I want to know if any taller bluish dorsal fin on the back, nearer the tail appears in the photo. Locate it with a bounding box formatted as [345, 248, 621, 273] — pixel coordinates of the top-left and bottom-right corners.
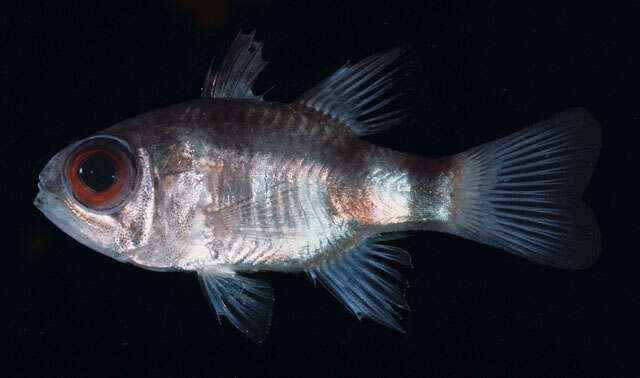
[296, 47, 405, 136]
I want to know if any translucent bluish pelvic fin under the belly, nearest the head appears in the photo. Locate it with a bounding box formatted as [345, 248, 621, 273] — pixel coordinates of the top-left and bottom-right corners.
[198, 269, 274, 344]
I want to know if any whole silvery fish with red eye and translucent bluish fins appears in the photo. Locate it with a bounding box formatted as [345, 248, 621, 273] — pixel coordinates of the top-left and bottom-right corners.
[34, 32, 601, 344]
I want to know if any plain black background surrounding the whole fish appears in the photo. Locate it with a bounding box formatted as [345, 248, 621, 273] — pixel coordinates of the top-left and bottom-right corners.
[0, 0, 640, 377]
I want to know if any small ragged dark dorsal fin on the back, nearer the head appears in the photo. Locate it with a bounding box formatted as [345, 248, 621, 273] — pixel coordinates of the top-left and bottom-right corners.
[202, 31, 267, 101]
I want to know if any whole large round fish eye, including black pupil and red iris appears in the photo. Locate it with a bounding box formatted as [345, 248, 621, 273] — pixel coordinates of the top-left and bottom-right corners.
[64, 137, 136, 210]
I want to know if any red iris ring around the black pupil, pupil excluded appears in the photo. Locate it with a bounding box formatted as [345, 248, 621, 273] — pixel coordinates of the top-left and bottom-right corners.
[65, 138, 135, 210]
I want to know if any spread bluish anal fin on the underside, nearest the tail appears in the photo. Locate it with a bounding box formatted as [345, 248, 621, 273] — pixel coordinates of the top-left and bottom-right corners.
[307, 236, 411, 333]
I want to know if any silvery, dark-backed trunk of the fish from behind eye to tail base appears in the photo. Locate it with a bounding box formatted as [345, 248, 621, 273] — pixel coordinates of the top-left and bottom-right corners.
[38, 99, 454, 271]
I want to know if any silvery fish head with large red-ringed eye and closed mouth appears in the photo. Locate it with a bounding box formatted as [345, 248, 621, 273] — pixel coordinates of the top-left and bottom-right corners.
[34, 134, 163, 269]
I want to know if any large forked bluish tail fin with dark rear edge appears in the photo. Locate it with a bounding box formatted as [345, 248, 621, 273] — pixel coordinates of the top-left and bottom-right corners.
[449, 109, 601, 269]
